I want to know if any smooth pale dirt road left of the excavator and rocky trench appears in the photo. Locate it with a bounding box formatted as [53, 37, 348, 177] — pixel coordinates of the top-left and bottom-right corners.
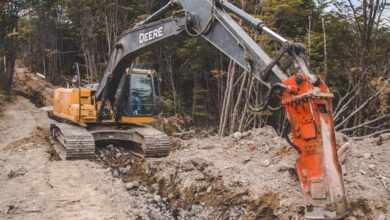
[0, 96, 136, 219]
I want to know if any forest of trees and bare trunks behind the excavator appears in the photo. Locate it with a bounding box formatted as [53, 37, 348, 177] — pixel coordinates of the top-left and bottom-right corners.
[0, 0, 390, 139]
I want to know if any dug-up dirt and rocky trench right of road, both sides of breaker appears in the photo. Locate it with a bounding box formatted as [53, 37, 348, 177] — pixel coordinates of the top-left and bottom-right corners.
[99, 127, 390, 219]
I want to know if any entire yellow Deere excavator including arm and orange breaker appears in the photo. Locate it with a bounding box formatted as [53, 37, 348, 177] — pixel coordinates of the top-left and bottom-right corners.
[50, 0, 349, 219]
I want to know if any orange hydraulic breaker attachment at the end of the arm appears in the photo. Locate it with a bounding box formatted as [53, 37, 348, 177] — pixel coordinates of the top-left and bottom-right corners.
[281, 73, 349, 219]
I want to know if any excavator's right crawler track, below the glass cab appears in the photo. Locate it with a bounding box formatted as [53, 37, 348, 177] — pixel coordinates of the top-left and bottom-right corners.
[88, 124, 171, 158]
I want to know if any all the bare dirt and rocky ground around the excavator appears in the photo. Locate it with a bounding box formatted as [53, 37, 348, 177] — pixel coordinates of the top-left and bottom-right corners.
[0, 62, 390, 220]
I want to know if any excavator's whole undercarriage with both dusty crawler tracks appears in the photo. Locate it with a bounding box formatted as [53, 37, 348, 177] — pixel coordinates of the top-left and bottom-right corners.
[50, 123, 171, 160]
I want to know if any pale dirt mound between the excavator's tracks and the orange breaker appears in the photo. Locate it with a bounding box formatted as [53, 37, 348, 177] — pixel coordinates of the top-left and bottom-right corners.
[140, 128, 303, 219]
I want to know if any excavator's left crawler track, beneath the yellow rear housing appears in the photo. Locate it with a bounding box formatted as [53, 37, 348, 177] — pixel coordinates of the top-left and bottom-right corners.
[50, 123, 95, 160]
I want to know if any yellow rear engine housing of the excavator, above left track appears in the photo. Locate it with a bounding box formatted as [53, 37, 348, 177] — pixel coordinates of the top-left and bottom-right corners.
[53, 88, 96, 123]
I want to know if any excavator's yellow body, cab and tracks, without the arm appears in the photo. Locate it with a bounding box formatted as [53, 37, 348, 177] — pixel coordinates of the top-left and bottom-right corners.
[49, 69, 171, 160]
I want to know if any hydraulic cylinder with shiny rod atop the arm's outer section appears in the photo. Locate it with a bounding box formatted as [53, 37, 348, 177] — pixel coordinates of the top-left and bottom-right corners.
[215, 0, 287, 43]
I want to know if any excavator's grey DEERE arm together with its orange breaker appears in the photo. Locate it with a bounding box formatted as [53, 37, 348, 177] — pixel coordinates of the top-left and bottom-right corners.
[96, 0, 348, 219]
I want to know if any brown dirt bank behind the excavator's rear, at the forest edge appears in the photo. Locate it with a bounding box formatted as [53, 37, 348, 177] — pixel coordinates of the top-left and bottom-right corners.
[13, 60, 55, 107]
